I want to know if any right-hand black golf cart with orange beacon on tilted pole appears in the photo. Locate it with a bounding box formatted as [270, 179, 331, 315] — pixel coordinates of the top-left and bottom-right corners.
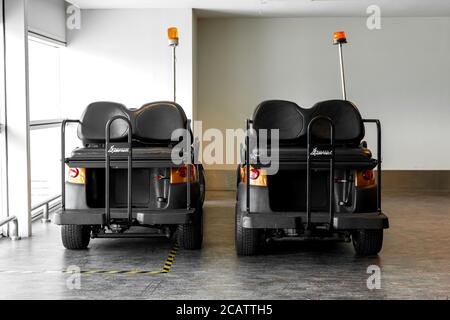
[235, 33, 389, 256]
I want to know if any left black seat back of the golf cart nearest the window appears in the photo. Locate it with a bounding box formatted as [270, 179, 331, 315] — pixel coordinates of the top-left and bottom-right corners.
[77, 101, 130, 145]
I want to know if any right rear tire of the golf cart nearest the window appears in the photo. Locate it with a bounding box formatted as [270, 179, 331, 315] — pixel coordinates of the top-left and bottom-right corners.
[178, 206, 203, 250]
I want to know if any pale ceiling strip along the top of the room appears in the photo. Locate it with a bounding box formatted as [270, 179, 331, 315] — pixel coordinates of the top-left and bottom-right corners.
[68, 0, 450, 17]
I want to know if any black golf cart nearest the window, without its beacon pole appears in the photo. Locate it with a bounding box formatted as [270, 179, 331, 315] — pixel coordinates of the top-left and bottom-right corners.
[54, 102, 205, 249]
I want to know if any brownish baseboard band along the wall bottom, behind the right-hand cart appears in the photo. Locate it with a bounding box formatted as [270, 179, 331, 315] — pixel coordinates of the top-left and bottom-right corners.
[206, 169, 450, 191]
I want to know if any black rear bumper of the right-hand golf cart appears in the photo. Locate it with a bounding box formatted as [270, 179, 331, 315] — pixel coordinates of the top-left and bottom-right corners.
[243, 212, 389, 231]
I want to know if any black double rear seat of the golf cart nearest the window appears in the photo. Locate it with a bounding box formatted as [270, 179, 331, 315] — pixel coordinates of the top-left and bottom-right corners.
[66, 102, 192, 167]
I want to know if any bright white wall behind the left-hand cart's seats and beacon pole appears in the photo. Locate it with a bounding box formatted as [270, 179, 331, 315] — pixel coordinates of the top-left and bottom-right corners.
[61, 9, 193, 118]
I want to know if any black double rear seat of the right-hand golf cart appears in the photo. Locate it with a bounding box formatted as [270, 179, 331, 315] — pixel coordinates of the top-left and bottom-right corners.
[250, 100, 377, 168]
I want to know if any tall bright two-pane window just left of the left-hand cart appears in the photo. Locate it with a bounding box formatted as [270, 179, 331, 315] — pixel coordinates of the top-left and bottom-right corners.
[28, 39, 61, 206]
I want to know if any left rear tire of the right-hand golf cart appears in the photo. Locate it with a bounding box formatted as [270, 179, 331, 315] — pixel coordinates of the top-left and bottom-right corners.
[235, 205, 259, 256]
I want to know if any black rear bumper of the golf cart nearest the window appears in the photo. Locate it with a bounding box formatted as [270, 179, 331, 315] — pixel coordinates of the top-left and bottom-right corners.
[53, 209, 195, 225]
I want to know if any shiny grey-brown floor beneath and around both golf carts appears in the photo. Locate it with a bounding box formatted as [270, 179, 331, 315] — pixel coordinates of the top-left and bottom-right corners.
[0, 192, 450, 299]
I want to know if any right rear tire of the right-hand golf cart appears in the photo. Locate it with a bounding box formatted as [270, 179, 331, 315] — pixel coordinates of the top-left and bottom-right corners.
[352, 229, 383, 256]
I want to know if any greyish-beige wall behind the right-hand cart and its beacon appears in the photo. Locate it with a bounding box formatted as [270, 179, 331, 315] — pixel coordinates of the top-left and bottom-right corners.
[197, 18, 450, 169]
